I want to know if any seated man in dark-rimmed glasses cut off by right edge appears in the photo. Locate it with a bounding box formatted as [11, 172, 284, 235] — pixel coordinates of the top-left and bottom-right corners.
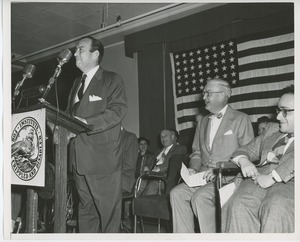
[222, 86, 295, 233]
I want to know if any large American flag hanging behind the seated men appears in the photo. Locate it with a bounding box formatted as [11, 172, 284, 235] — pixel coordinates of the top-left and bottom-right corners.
[170, 30, 294, 134]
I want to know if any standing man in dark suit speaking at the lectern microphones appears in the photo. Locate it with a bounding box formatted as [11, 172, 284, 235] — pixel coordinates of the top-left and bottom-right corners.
[67, 37, 127, 233]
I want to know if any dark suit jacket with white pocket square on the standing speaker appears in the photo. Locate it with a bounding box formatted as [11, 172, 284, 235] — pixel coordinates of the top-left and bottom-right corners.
[66, 67, 127, 174]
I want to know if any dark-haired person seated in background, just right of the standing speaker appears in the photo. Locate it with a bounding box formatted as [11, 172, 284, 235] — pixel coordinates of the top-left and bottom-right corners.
[135, 137, 153, 178]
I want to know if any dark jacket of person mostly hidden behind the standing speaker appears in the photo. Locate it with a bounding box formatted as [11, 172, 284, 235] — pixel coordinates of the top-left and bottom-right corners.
[121, 129, 139, 192]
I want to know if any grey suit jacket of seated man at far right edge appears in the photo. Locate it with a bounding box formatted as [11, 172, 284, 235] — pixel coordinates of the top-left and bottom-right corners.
[233, 123, 294, 182]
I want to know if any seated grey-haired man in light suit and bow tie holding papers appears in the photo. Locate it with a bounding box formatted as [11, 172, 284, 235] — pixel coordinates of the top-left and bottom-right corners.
[171, 79, 254, 233]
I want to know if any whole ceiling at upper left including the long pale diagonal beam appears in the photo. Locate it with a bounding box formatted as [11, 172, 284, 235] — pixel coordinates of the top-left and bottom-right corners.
[10, 1, 220, 71]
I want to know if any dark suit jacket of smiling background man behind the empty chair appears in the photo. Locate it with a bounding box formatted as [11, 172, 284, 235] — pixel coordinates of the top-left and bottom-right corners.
[147, 144, 187, 173]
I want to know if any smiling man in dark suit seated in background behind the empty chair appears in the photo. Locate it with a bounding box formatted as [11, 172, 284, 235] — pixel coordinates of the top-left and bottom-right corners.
[143, 129, 187, 195]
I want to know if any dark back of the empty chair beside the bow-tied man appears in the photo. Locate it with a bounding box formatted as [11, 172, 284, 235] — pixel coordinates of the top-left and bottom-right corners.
[165, 154, 189, 194]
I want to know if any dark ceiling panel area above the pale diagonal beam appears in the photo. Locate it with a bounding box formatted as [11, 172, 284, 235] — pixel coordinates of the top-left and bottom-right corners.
[11, 2, 170, 56]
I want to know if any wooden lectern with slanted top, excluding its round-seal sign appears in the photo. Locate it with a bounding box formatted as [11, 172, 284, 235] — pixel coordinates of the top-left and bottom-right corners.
[14, 100, 92, 233]
